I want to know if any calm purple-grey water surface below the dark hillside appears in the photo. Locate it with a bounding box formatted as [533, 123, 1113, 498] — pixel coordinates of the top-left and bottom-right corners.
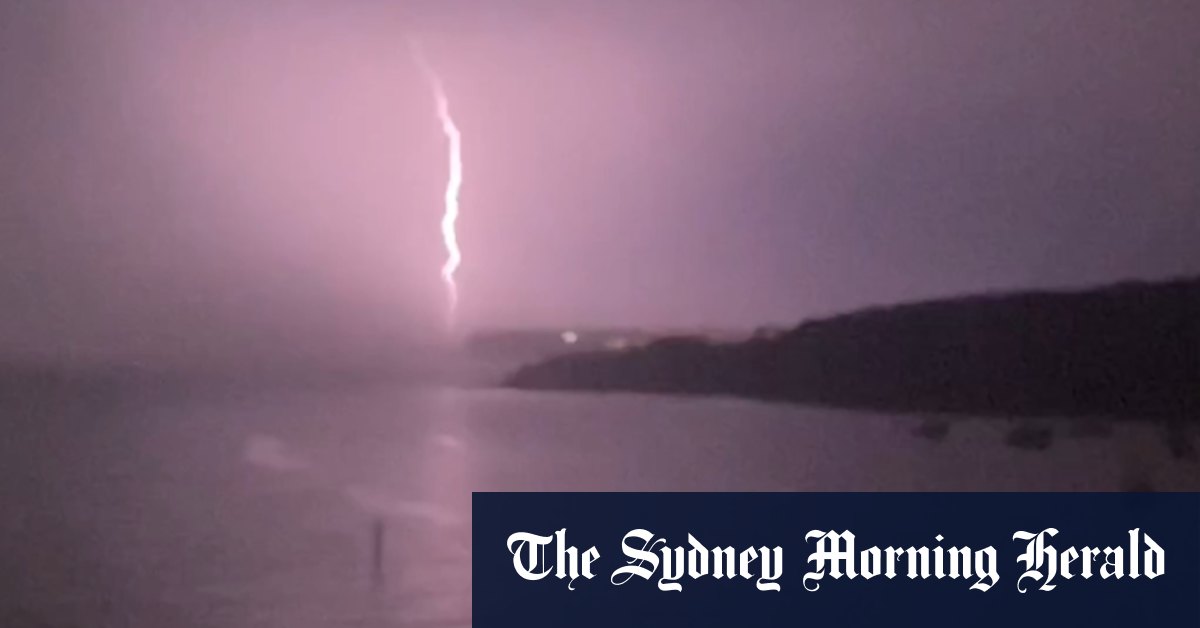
[0, 385, 1200, 628]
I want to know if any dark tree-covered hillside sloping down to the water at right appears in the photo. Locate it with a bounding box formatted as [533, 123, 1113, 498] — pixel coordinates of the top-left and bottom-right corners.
[508, 279, 1200, 417]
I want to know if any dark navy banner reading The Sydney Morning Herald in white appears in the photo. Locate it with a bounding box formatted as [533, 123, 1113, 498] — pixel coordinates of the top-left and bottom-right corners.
[473, 494, 1200, 628]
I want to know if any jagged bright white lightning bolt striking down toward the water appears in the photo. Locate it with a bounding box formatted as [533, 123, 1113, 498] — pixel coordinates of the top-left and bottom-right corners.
[408, 38, 462, 327]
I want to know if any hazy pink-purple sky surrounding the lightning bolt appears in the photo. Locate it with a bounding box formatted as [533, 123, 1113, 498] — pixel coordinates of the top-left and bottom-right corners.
[0, 0, 1200, 357]
